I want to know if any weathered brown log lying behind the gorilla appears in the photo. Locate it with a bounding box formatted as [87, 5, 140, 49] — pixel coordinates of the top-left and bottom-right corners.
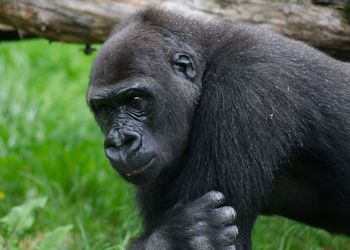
[0, 0, 350, 59]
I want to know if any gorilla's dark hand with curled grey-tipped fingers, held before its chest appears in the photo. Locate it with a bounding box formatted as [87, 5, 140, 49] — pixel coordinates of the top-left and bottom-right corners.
[131, 191, 238, 250]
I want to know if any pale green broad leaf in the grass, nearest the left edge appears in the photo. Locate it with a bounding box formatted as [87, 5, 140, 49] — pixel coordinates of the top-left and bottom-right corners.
[0, 197, 47, 234]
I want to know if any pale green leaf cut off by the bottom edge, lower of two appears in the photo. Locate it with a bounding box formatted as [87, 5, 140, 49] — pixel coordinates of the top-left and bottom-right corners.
[37, 225, 73, 250]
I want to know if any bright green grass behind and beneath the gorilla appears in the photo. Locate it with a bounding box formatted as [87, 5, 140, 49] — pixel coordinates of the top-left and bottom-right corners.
[0, 40, 350, 250]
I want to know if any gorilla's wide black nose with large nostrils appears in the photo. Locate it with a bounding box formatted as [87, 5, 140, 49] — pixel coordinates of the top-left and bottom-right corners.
[105, 131, 141, 161]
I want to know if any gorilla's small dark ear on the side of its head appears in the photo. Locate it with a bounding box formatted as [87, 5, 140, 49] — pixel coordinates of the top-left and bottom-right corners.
[171, 53, 196, 80]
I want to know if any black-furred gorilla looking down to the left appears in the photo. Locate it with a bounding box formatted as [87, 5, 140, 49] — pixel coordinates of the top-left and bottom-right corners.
[87, 7, 350, 250]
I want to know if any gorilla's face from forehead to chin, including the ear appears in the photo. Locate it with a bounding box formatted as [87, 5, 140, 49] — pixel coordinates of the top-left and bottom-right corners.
[87, 23, 200, 184]
